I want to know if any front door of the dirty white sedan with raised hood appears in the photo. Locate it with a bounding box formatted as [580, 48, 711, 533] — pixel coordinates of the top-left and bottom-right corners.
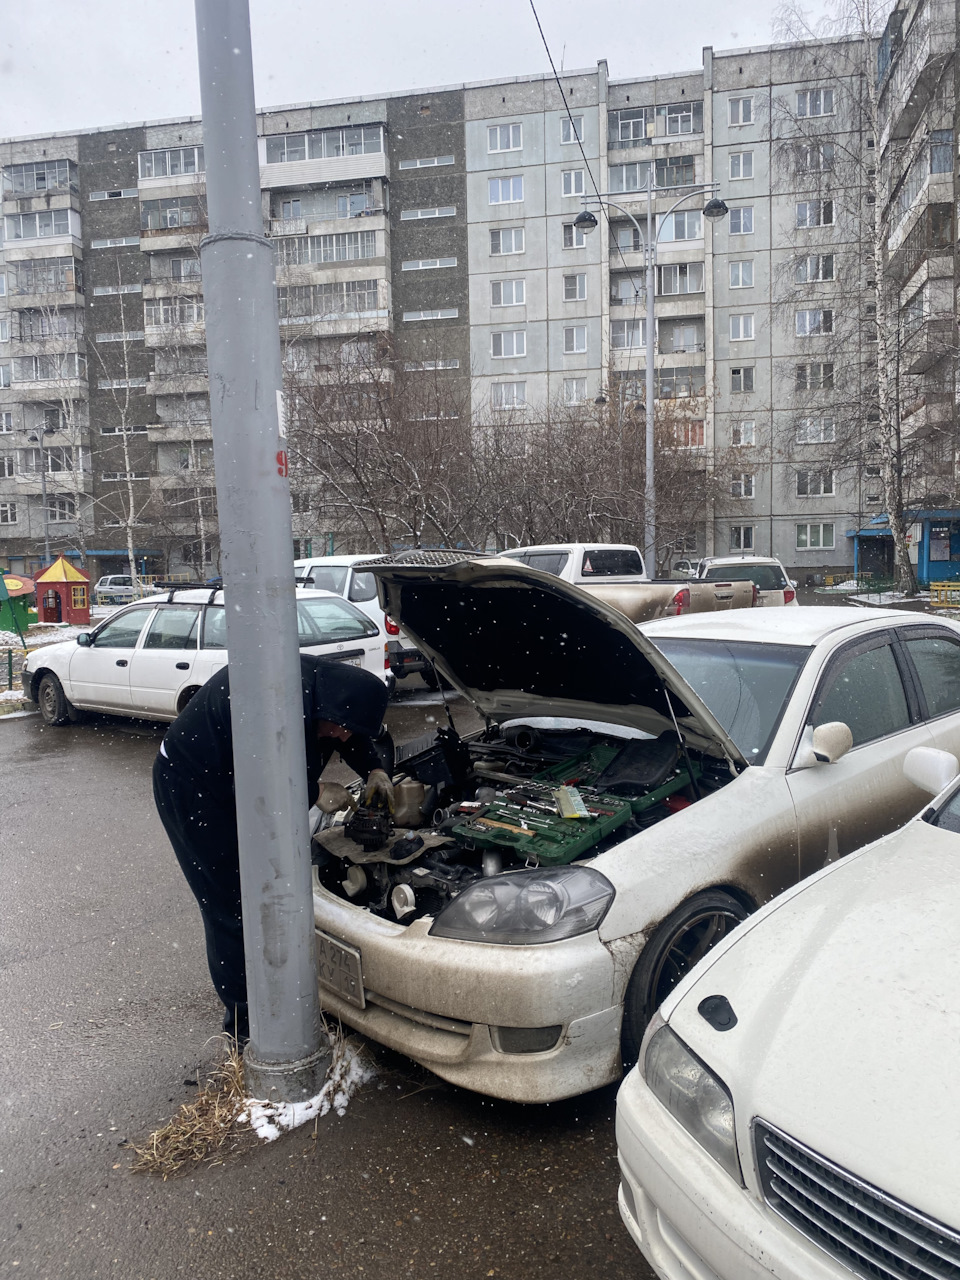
[787, 631, 931, 876]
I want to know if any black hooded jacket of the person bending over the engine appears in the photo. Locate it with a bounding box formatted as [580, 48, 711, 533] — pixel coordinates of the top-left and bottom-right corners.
[161, 654, 387, 806]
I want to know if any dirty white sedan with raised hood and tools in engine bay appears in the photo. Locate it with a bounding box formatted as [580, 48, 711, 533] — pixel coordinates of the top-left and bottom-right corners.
[308, 553, 960, 1102]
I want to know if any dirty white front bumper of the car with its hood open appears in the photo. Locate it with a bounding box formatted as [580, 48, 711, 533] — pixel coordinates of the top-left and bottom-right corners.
[314, 881, 622, 1102]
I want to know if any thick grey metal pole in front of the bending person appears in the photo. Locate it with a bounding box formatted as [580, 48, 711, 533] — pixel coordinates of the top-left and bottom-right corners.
[196, 0, 329, 1101]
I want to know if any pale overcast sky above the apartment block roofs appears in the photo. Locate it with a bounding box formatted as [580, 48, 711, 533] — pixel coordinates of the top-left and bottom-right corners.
[0, 0, 839, 137]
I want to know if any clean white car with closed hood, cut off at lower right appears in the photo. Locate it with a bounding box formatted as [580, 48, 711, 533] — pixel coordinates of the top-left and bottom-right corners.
[617, 747, 960, 1280]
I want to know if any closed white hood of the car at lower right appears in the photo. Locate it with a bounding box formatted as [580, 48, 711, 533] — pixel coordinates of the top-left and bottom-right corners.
[664, 820, 960, 1229]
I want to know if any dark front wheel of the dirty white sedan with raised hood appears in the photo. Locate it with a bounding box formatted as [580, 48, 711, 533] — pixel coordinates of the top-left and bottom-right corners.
[621, 890, 750, 1070]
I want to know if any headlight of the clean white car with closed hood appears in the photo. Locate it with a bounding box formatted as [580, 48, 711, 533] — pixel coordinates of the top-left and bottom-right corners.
[643, 1024, 744, 1187]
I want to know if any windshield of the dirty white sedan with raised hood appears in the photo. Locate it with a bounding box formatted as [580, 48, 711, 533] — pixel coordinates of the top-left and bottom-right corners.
[650, 636, 810, 764]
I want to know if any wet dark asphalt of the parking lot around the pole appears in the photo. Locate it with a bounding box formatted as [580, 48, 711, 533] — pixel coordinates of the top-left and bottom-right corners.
[0, 677, 652, 1280]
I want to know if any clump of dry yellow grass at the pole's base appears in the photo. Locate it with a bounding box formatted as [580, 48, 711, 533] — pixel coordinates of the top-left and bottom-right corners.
[131, 1041, 251, 1181]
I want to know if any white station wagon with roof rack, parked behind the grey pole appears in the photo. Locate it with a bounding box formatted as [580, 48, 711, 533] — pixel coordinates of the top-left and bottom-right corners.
[23, 588, 390, 724]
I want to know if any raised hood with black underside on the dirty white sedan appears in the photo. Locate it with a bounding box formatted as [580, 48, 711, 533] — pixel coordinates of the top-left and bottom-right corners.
[364, 552, 748, 768]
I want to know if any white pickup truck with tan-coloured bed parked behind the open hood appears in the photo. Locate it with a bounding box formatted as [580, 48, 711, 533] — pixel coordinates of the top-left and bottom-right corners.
[502, 543, 758, 622]
